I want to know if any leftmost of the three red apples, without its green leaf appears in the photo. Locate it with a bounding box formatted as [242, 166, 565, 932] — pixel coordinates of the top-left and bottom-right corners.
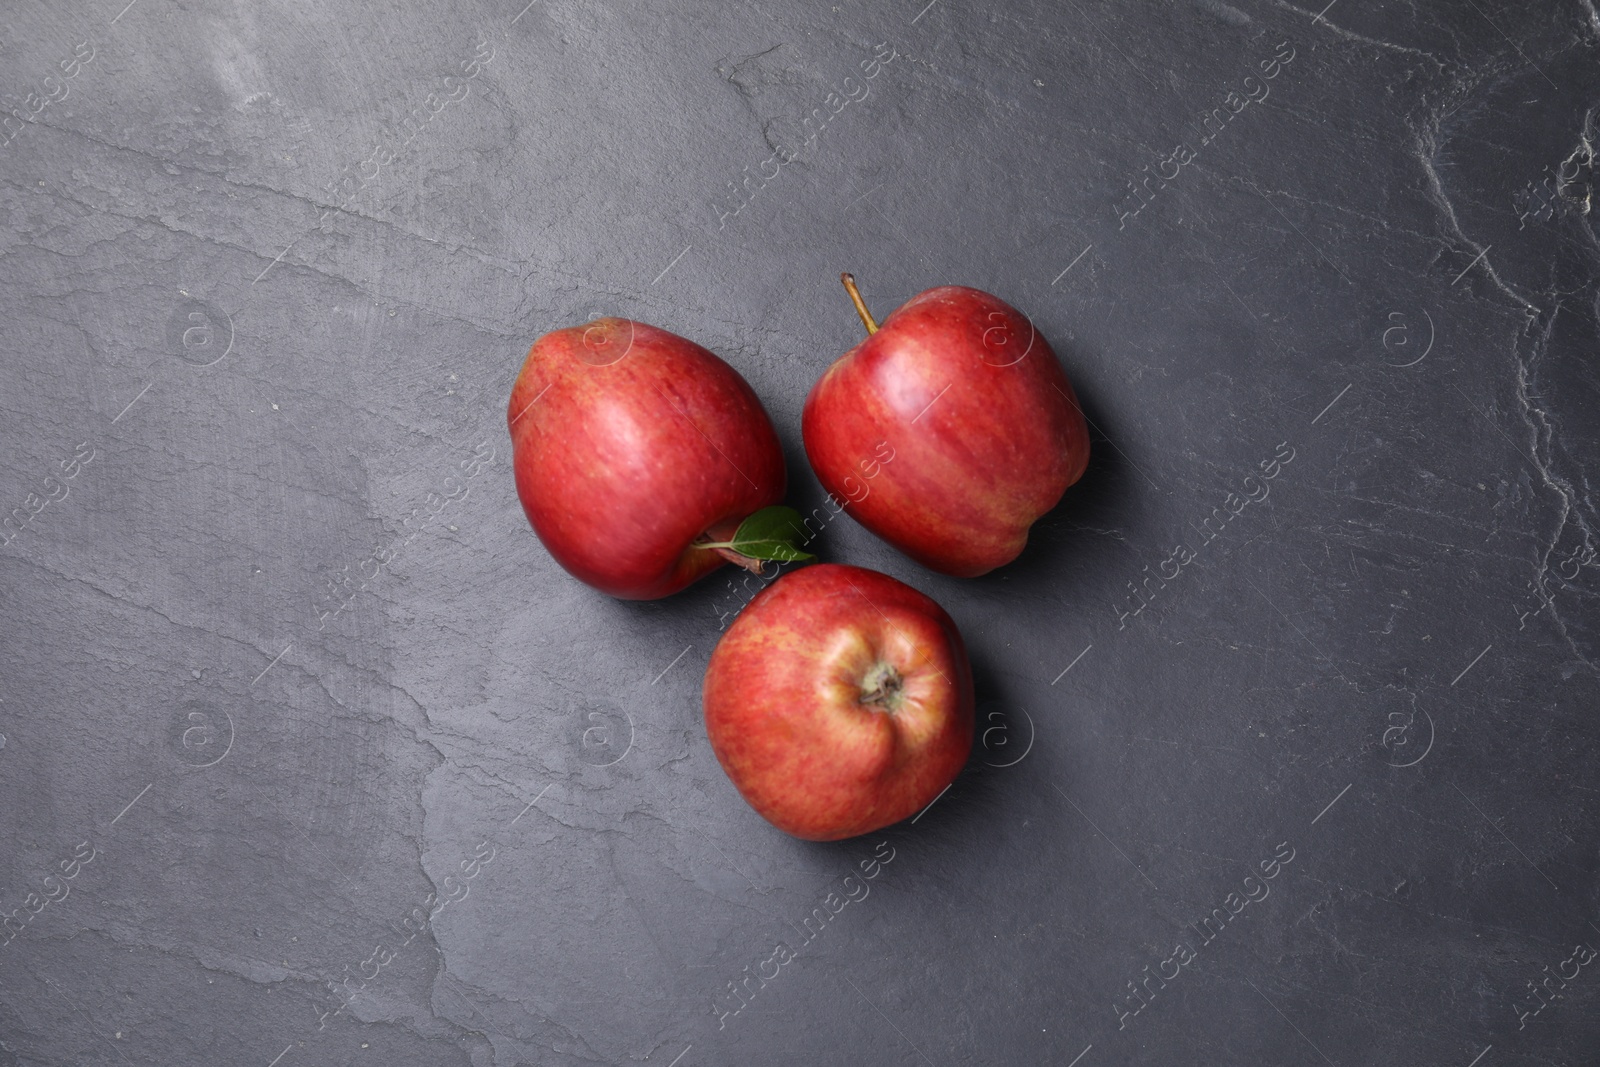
[506, 318, 786, 600]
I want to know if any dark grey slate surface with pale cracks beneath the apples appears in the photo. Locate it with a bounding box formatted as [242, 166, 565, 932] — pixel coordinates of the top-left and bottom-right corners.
[0, 0, 1600, 1067]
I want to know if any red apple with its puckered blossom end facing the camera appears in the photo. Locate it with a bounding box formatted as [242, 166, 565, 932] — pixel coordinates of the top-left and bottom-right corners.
[704, 563, 973, 841]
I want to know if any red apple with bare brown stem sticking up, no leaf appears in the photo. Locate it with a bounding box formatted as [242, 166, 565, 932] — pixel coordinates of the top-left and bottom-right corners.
[800, 274, 1090, 577]
